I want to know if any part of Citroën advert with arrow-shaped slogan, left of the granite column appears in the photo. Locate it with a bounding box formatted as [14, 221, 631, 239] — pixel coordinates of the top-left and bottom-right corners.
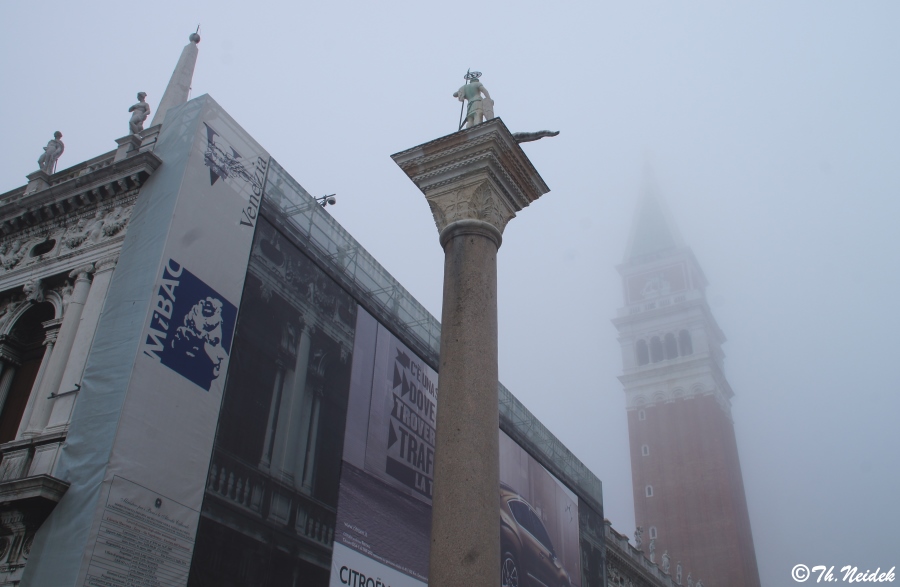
[331, 308, 438, 587]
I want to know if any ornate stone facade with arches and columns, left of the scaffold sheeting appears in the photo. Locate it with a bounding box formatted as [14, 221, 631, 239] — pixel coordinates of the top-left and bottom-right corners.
[0, 120, 161, 584]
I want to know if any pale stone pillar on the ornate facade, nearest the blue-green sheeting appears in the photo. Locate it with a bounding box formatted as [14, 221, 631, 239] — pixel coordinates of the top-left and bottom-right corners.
[47, 255, 118, 432]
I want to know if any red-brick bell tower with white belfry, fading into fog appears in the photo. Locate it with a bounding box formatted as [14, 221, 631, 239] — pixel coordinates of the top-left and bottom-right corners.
[613, 187, 760, 587]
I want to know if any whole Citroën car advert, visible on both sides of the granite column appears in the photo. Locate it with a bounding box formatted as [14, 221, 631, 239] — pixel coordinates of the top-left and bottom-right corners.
[330, 309, 581, 587]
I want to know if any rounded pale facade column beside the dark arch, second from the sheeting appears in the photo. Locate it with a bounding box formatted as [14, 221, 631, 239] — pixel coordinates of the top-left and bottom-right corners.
[25, 263, 94, 436]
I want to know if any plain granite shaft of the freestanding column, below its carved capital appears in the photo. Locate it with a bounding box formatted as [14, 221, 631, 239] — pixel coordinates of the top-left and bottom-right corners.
[428, 223, 500, 587]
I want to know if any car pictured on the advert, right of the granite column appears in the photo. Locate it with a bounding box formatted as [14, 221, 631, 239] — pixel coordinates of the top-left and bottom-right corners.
[500, 483, 572, 587]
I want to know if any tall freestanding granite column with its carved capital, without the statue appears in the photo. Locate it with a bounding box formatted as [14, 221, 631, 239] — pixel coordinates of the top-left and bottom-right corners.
[392, 119, 549, 587]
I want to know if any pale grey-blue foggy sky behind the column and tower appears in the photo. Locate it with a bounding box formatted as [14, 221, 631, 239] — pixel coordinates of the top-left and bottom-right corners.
[0, 0, 900, 586]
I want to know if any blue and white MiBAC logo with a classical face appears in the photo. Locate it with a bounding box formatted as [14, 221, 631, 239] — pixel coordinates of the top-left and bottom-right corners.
[143, 259, 237, 391]
